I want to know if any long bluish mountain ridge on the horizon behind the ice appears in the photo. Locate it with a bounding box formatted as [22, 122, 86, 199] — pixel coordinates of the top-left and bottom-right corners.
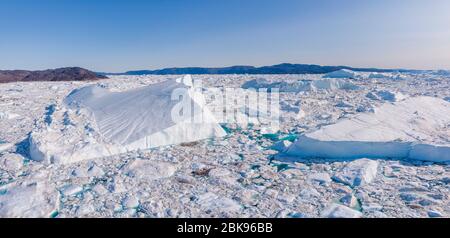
[121, 63, 405, 75]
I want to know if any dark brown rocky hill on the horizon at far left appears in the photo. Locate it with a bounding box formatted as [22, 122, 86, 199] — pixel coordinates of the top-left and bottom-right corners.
[0, 67, 107, 83]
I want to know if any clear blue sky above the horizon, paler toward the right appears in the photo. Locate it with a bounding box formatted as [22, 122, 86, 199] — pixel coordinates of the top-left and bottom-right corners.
[0, 0, 450, 72]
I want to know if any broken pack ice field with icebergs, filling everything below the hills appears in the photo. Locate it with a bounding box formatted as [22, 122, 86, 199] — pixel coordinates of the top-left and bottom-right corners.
[0, 70, 450, 218]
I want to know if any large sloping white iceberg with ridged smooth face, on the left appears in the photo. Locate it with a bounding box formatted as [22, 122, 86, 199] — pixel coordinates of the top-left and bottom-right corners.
[30, 77, 226, 163]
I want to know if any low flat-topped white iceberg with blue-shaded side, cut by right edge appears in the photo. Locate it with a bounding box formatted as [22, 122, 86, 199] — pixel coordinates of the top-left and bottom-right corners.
[286, 97, 450, 162]
